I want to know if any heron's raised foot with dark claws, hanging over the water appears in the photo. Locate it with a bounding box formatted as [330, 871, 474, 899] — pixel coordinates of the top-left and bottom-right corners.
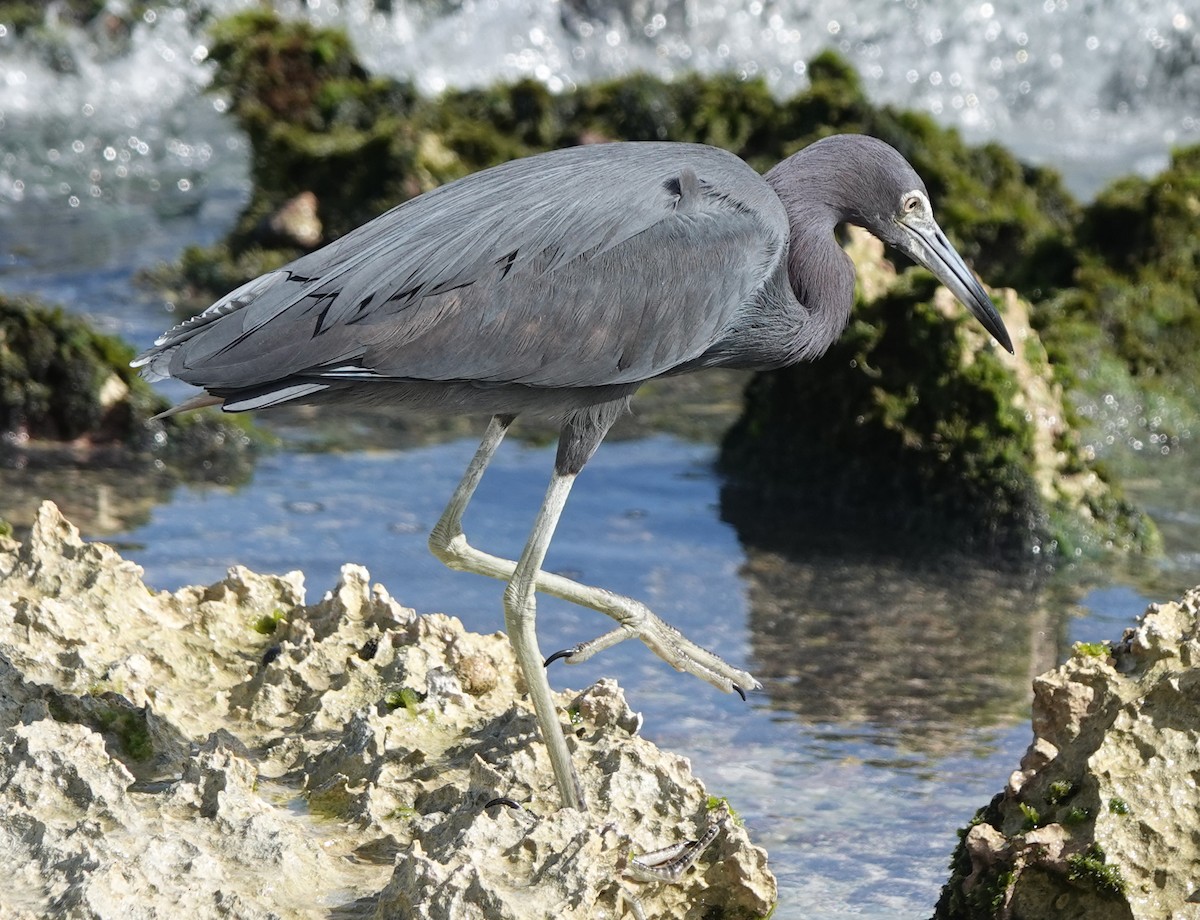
[545, 599, 762, 699]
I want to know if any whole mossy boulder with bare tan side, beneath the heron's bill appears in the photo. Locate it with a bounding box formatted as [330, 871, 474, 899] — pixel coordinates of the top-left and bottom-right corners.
[720, 230, 1157, 558]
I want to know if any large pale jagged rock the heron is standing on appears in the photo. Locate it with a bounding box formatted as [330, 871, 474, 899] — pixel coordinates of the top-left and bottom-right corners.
[0, 503, 775, 920]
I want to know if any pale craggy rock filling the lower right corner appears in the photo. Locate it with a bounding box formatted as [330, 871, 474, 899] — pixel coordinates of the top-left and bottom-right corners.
[937, 588, 1200, 920]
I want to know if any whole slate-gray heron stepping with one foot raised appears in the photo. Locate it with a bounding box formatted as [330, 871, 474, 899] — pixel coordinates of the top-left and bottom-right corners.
[133, 134, 1012, 808]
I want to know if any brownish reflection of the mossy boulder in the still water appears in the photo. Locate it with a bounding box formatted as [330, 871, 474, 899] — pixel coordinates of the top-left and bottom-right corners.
[721, 487, 1072, 762]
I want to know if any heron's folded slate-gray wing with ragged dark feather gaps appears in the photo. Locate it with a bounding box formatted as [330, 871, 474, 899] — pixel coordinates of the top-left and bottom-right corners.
[134, 144, 787, 405]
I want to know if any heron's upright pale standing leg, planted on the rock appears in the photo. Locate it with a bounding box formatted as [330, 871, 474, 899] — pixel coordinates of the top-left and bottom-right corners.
[504, 471, 587, 811]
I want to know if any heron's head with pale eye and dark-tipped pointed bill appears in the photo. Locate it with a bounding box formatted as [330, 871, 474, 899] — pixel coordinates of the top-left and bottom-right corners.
[809, 134, 1013, 351]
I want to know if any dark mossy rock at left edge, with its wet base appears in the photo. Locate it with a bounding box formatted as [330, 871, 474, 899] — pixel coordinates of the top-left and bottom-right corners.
[0, 294, 266, 531]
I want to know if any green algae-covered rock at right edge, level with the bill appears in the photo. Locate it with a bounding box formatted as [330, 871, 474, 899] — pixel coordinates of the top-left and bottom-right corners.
[1038, 146, 1200, 453]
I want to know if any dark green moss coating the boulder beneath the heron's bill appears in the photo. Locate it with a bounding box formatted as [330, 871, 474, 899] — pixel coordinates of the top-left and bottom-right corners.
[720, 270, 1051, 554]
